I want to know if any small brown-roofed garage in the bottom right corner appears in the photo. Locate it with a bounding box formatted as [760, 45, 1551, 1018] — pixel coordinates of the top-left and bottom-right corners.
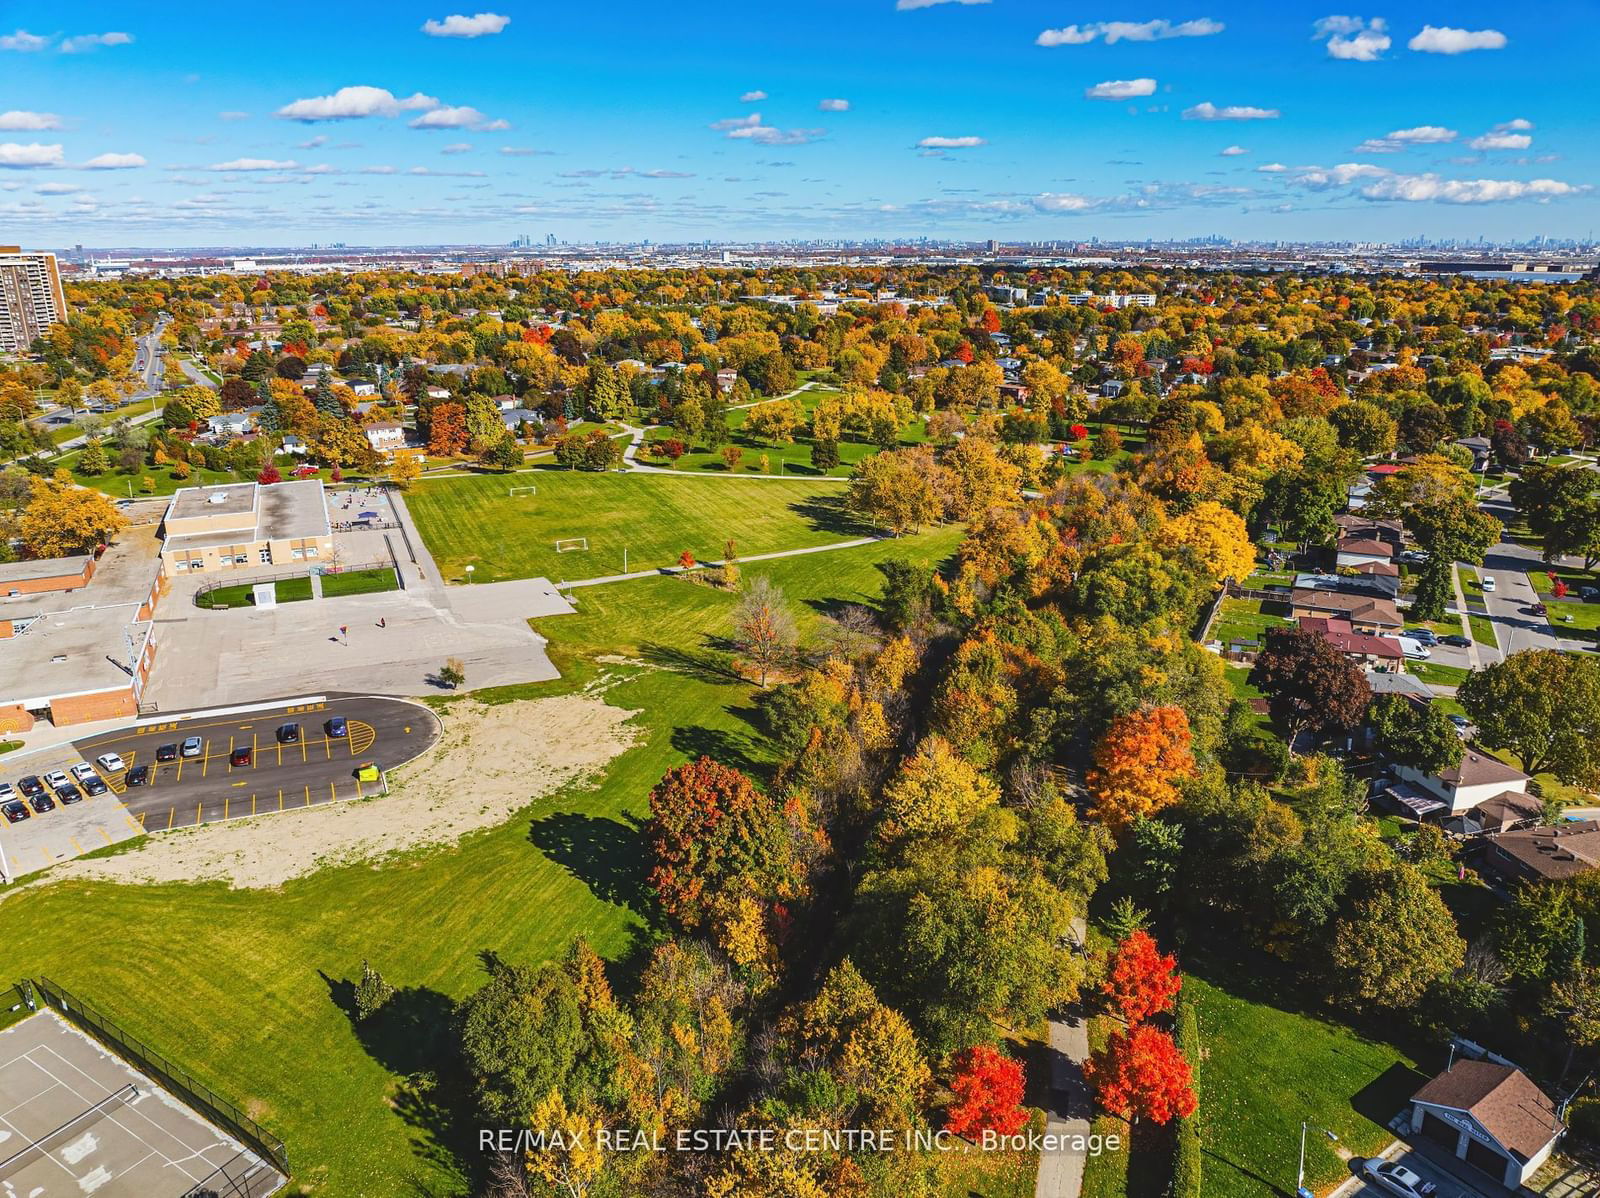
[1411, 1059, 1566, 1190]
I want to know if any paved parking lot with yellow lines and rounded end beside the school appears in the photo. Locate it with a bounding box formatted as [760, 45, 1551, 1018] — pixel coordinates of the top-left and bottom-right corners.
[0, 696, 440, 877]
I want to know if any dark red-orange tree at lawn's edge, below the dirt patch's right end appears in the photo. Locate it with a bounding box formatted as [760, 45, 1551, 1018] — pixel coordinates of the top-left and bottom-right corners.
[645, 757, 782, 931]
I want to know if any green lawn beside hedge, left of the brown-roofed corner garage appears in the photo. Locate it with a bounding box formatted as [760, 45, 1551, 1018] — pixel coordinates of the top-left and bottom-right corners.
[1184, 953, 1424, 1198]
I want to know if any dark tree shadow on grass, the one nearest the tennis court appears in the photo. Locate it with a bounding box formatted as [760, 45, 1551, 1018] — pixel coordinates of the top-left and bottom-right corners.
[318, 971, 477, 1193]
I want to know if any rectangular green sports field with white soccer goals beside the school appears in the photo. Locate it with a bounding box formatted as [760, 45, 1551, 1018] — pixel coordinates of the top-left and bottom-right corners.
[406, 470, 870, 582]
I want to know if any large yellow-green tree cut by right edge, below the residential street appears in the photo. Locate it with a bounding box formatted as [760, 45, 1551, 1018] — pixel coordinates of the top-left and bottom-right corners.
[1458, 649, 1600, 787]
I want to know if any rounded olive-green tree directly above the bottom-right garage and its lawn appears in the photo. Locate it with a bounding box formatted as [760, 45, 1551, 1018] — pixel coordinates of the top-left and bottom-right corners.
[1326, 862, 1466, 1011]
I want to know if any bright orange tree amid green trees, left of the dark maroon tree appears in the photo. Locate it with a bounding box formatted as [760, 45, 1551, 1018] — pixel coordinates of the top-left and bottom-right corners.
[1088, 707, 1195, 832]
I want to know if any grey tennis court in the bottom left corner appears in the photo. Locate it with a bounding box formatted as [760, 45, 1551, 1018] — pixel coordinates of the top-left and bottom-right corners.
[0, 1008, 283, 1198]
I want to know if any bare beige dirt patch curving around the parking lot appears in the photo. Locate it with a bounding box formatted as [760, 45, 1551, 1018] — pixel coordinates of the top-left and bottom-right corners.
[28, 691, 638, 889]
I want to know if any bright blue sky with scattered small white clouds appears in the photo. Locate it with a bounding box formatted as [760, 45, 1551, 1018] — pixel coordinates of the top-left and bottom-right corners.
[0, 0, 1600, 246]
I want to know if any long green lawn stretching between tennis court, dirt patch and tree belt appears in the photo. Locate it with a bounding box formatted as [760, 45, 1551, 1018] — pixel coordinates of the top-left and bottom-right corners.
[0, 527, 960, 1198]
